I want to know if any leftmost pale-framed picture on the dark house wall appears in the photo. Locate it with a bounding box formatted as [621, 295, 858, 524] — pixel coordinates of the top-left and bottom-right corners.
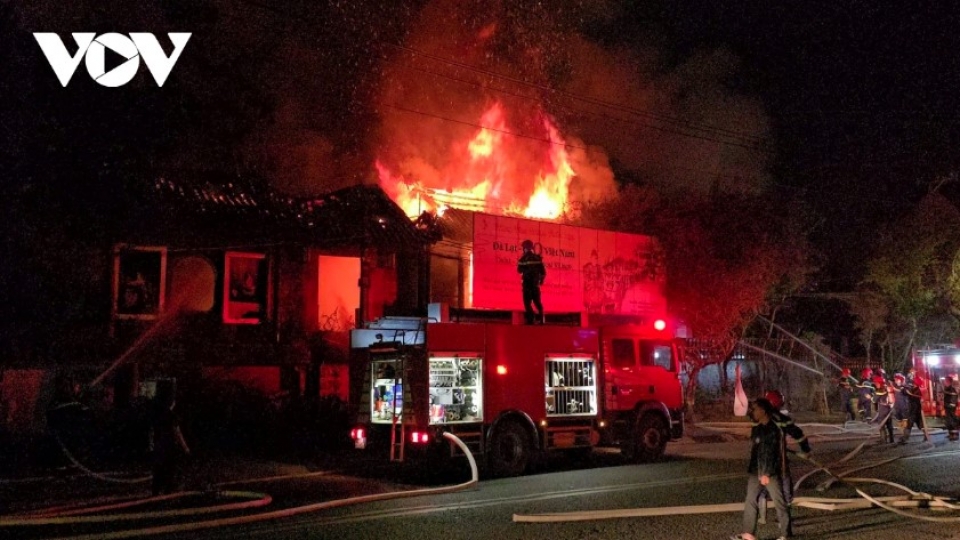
[113, 244, 167, 319]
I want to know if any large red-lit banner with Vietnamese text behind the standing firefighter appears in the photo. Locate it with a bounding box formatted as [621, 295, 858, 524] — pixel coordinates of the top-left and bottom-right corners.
[472, 213, 666, 315]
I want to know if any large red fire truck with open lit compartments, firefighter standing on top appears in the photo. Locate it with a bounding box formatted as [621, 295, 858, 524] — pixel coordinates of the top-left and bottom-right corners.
[351, 308, 684, 476]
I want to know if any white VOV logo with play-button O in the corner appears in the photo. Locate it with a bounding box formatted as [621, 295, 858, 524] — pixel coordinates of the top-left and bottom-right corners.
[33, 32, 191, 88]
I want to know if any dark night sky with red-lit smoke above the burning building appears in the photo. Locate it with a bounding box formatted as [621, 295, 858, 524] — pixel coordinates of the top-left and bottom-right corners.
[0, 0, 960, 296]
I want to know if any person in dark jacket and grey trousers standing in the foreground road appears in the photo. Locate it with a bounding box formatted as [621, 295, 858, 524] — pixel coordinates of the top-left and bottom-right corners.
[731, 398, 793, 540]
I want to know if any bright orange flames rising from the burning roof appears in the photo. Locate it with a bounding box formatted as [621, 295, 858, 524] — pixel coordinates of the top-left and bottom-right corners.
[376, 103, 576, 220]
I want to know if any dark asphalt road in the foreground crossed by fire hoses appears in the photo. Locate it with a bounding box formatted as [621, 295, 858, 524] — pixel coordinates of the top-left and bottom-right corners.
[5, 428, 960, 540]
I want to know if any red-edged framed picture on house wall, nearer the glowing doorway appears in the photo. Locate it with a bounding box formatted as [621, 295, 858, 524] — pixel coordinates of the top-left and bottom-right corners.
[223, 251, 269, 324]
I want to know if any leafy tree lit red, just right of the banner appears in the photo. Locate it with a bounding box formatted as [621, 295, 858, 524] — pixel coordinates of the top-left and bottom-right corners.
[583, 187, 815, 407]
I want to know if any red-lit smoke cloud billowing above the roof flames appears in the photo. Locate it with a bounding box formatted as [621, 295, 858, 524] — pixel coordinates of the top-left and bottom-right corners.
[225, 0, 771, 201]
